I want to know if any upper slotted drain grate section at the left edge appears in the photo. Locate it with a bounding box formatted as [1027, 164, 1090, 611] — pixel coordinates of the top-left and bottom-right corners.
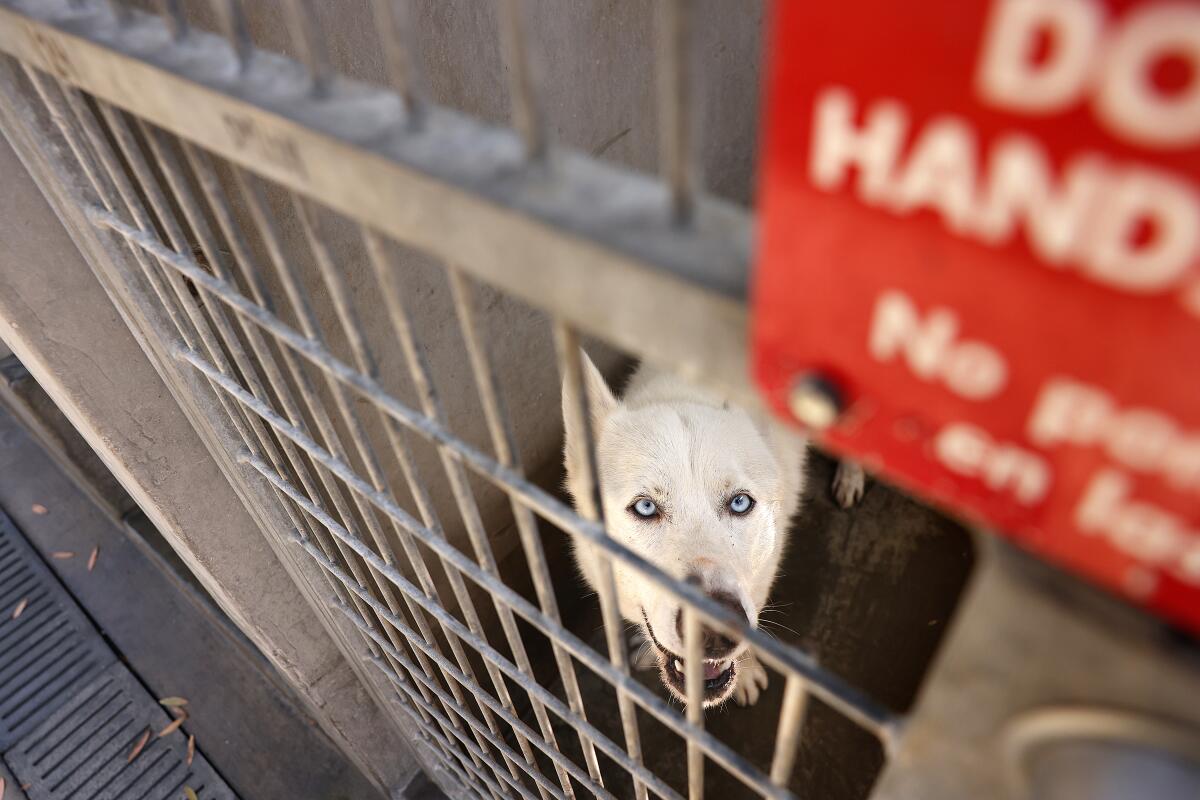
[0, 513, 116, 752]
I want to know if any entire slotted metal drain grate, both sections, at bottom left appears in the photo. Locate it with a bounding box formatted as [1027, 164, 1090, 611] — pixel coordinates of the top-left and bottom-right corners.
[0, 513, 235, 800]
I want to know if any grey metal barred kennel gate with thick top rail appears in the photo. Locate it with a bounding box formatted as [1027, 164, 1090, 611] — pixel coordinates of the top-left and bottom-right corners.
[0, 0, 898, 798]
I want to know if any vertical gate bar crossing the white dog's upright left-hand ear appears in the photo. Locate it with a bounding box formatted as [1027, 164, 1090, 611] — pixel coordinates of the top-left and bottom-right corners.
[553, 319, 646, 800]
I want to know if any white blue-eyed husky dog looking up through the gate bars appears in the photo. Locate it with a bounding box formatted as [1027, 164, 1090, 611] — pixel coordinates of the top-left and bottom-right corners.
[563, 355, 864, 708]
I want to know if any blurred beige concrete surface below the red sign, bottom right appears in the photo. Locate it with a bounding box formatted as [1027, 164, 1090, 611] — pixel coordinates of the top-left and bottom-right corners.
[876, 536, 1200, 800]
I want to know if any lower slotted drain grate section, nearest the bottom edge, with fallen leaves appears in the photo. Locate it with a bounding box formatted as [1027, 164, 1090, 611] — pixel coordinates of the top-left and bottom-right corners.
[5, 663, 234, 800]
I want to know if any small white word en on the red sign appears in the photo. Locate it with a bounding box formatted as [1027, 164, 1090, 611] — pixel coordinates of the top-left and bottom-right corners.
[934, 422, 1050, 505]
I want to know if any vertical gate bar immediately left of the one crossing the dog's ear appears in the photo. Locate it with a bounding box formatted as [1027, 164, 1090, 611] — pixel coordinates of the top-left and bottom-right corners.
[441, 264, 609, 786]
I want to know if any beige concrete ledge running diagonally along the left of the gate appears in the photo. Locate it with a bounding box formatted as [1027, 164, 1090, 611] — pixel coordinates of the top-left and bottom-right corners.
[0, 130, 414, 786]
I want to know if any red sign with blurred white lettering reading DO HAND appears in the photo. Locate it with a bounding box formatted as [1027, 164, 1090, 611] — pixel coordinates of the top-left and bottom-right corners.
[754, 0, 1200, 630]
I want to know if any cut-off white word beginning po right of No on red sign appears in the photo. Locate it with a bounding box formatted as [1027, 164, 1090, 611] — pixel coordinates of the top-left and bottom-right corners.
[1027, 378, 1200, 492]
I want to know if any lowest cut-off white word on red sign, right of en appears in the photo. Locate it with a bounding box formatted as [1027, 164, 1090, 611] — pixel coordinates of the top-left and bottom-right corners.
[1075, 469, 1200, 585]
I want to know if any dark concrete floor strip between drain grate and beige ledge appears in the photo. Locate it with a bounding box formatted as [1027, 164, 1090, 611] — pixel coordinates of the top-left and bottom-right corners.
[0, 395, 380, 800]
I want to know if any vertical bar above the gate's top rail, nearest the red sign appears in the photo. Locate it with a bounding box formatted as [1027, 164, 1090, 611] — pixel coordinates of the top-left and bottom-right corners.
[658, 0, 698, 225]
